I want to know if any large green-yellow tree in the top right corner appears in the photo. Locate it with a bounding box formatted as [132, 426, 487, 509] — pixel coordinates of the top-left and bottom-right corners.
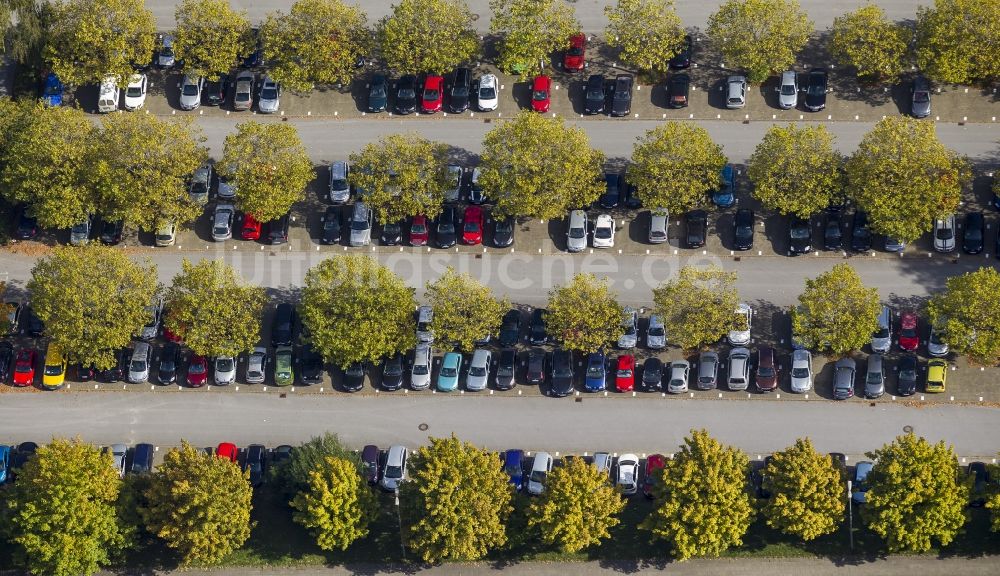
[916, 0, 1000, 84]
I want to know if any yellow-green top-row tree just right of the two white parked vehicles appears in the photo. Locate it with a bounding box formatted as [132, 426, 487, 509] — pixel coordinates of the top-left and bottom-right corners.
[174, 0, 254, 80]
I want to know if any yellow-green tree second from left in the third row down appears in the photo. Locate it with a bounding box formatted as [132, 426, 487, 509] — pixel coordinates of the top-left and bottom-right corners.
[164, 258, 267, 358]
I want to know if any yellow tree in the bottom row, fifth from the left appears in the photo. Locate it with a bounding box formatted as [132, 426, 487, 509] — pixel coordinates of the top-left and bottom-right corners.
[528, 458, 625, 554]
